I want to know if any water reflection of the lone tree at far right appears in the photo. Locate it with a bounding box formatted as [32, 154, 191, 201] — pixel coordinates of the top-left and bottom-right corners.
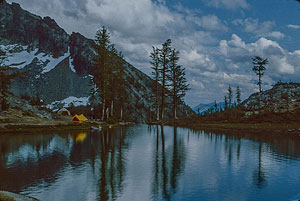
[253, 143, 266, 188]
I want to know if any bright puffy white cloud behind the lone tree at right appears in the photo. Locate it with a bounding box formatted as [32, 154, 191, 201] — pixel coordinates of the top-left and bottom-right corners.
[219, 34, 300, 79]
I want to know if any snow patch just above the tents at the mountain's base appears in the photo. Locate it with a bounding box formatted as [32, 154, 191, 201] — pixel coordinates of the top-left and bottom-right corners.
[47, 96, 89, 111]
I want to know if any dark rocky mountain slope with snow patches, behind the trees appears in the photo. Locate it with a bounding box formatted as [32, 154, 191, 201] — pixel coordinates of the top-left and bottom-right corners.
[0, 1, 193, 121]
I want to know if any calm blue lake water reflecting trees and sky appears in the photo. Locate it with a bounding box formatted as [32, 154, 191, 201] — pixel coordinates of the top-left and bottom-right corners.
[0, 125, 300, 201]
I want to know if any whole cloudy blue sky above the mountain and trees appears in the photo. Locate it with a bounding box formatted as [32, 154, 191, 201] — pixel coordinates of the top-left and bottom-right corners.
[8, 0, 300, 106]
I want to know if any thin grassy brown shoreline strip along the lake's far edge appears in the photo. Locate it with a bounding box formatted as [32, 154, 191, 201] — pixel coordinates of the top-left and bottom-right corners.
[0, 121, 300, 137]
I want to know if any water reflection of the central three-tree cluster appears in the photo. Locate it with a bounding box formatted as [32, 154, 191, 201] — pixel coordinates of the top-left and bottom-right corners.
[152, 126, 186, 200]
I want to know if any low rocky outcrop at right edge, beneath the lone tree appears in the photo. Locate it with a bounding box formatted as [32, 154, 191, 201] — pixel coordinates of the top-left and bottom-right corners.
[241, 83, 300, 114]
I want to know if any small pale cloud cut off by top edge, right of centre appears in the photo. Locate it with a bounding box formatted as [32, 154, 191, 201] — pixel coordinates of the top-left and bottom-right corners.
[203, 0, 250, 10]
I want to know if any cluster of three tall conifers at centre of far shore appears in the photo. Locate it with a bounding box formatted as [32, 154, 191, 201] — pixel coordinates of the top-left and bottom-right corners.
[150, 39, 189, 120]
